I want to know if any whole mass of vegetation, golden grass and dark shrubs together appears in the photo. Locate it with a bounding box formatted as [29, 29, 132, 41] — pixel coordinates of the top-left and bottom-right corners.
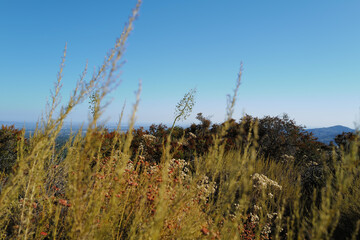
[0, 1, 360, 239]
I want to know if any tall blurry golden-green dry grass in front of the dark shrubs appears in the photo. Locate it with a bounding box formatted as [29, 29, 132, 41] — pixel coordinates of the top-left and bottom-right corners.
[0, 1, 360, 239]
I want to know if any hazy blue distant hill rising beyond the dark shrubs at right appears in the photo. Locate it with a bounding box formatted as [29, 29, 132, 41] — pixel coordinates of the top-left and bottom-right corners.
[306, 125, 355, 144]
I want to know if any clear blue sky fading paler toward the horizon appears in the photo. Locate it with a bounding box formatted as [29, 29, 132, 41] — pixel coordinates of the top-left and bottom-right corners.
[0, 0, 360, 127]
